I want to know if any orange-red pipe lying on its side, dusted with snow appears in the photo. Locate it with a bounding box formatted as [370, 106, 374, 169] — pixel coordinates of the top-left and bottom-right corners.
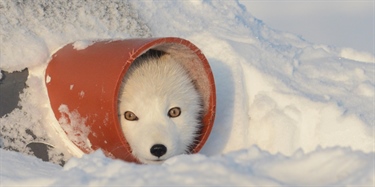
[45, 37, 216, 162]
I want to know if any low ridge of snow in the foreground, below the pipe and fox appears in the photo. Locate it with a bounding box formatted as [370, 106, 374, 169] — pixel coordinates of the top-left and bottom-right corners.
[0, 146, 375, 186]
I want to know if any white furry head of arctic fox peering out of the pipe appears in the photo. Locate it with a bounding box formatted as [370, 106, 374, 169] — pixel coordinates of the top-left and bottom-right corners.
[119, 50, 202, 164]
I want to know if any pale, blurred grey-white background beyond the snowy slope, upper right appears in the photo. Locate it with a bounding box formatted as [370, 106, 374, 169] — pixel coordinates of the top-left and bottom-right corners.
[240, 0, 375, 54]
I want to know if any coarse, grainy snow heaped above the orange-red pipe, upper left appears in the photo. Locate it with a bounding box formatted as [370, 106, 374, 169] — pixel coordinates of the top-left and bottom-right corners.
[0, 0, 151, 71]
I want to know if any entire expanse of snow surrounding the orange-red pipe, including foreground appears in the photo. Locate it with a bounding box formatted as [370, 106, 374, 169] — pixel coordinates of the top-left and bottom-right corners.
[0, 0, 375, 186]
